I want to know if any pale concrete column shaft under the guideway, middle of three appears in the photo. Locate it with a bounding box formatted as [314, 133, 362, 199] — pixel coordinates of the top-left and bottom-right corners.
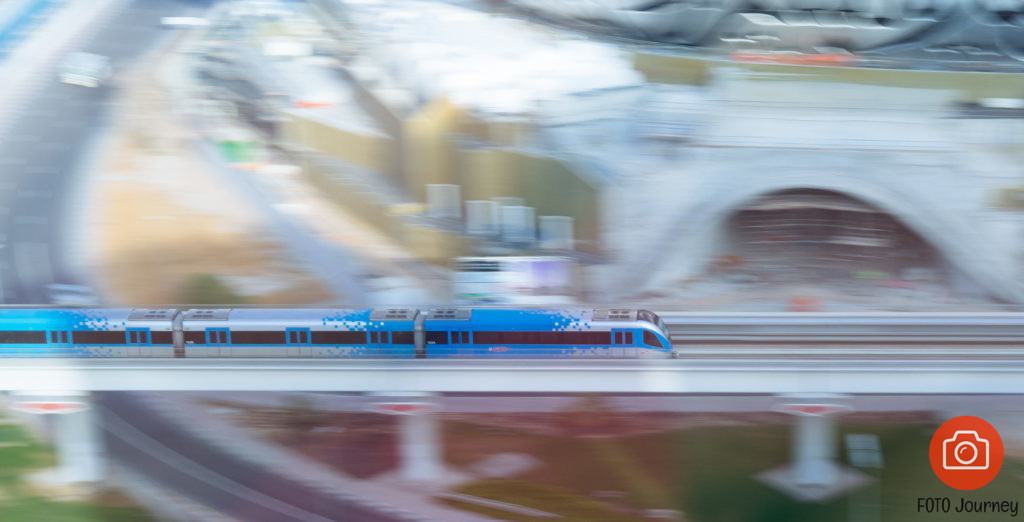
[398, 411, 444, 481]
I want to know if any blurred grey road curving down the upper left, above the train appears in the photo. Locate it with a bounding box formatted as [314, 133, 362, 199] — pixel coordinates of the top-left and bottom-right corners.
[0, 0, 210, 304]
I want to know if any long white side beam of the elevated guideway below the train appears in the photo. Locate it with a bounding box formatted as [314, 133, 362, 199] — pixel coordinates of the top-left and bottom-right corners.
[6, 356, 1024, 394]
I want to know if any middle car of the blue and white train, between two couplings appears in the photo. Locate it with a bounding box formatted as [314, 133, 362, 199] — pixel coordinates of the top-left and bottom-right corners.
[182, 308, 416, 358]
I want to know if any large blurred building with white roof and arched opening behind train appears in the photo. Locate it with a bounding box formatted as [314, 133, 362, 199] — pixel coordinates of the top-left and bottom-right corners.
[195, 0, 1024, 301]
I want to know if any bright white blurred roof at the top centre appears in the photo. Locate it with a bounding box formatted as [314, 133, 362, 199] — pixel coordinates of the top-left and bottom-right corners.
[339, 0, 643, 115]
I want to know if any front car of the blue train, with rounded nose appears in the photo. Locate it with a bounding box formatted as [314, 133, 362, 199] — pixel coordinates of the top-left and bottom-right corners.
[424, 308, 672, 359]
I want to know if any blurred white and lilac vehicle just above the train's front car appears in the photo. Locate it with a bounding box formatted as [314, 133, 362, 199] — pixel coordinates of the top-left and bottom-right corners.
[452, 256, 577, 306]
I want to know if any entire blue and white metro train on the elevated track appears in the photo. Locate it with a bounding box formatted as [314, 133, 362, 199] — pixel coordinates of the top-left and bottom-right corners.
[0, 308, 675, 359]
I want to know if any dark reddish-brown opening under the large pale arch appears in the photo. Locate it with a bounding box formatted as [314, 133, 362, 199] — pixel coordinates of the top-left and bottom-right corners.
[708, 189, 948, 290]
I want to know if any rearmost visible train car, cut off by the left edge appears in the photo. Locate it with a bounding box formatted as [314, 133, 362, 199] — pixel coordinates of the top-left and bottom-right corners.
[0, 308, 178, 357]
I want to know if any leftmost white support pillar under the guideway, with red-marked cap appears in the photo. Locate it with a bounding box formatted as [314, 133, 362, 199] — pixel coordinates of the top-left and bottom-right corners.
[11, 393, 105, 485]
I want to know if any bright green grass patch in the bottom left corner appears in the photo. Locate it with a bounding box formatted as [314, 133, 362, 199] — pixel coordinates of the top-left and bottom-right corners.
[0, 417, 153, 522]
